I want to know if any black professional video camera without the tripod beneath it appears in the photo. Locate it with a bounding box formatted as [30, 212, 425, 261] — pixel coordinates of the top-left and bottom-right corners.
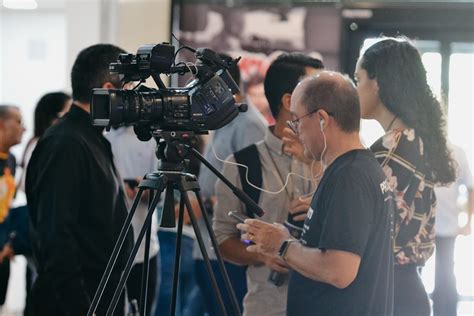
[91, 43, 246, 140]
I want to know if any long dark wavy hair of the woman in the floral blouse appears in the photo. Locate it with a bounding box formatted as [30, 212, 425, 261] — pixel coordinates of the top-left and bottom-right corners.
[361, 38, 456, 184]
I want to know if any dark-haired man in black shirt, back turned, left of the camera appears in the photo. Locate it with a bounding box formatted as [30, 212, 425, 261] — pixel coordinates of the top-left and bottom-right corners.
[26, 44, 133, 316]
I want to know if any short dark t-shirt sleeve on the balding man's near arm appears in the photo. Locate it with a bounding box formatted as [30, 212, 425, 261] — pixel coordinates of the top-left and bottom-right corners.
[319, 170, 375, 257]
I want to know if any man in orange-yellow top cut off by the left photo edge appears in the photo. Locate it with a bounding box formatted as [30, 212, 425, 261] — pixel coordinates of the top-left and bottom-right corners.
[0, 105, 25, 306]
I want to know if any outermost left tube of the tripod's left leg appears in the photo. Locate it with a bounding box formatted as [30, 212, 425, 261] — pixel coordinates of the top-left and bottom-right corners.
[87, 188, 144, 316]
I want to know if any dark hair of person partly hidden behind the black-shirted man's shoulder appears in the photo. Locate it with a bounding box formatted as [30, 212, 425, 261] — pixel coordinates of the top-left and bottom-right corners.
[34, 92, 71, 138]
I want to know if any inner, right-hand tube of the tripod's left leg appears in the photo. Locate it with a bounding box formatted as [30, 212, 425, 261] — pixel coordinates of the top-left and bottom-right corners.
[107, 189, 162, 316]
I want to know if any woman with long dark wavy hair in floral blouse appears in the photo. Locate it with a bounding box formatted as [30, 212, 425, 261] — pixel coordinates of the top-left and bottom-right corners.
[355, 38, 456, 316]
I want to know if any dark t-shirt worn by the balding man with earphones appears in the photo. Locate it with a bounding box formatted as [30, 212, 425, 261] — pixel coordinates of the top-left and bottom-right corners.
[287, 150, 394, 316]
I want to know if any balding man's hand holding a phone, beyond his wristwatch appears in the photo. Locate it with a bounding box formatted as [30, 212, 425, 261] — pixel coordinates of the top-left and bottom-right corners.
[237, 219, 291, 257]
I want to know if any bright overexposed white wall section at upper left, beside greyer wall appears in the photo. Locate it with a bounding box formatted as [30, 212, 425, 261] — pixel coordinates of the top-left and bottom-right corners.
[0, 10, 68, 158]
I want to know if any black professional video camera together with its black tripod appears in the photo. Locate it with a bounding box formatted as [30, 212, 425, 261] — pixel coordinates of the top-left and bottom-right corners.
[87, 43, 264, 316]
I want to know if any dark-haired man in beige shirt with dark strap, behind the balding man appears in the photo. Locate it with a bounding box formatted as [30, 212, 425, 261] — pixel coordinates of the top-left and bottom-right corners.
[214, 53, 321, 316]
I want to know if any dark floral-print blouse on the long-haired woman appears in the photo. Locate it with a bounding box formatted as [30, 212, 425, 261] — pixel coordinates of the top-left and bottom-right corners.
[371, 129, 436, 265]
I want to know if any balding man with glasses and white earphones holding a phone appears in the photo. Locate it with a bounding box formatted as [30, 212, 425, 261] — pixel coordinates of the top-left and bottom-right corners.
[238, 71, 394, 316]
